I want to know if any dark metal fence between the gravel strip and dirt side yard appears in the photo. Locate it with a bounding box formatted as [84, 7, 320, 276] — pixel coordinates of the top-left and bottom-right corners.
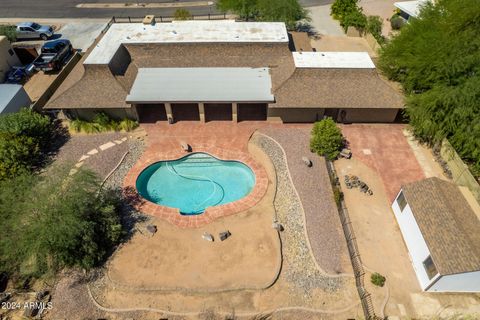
[327, 161, 381, 320]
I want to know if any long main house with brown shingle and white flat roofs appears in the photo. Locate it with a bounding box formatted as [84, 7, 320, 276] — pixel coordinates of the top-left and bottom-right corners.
[45, 20, 404, 122]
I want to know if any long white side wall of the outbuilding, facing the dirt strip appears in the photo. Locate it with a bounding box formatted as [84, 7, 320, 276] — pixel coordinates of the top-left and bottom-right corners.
[392, 193, 440, 290]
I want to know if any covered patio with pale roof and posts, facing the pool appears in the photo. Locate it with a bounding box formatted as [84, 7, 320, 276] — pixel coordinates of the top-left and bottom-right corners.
[126, 68, 274, 121]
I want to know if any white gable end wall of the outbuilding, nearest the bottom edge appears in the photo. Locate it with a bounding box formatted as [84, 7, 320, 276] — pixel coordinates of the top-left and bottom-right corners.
[428, 271, 480, 292]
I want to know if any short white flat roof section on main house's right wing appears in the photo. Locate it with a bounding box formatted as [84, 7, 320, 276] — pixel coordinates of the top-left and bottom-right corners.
[292, 52, 375, 69]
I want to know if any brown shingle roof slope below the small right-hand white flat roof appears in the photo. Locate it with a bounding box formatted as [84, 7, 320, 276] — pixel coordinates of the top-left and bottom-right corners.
[271, 68, 404, 109]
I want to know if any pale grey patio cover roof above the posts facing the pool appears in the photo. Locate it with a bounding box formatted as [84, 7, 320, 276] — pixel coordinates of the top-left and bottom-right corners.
[126, 68, 274, 103]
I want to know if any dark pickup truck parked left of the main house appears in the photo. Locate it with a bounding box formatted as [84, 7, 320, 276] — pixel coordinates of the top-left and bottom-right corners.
[33, 39, 73, 71]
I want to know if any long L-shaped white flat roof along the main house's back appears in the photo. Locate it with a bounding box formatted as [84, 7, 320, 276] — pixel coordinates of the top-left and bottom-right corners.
[84, 20, 289, 64]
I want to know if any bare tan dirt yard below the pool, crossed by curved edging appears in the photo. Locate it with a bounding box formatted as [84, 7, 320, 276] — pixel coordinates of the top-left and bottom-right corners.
[87, 139, 363, 319]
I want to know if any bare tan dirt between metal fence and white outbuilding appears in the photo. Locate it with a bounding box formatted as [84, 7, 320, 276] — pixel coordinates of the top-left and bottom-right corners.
[335, 138, 480, 318]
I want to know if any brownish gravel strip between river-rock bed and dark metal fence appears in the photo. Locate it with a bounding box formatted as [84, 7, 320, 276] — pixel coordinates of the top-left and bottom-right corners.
[261, 128, 352, 274]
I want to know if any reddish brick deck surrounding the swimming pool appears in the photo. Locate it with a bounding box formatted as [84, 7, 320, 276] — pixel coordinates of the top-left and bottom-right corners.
[124, 122, 268, 228]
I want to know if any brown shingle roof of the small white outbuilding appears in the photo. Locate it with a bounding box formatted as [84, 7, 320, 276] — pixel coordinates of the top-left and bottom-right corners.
[402, 177, 480, 275]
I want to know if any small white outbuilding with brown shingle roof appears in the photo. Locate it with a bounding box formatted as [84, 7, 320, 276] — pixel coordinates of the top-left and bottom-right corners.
[392, 177, 480, 292]
